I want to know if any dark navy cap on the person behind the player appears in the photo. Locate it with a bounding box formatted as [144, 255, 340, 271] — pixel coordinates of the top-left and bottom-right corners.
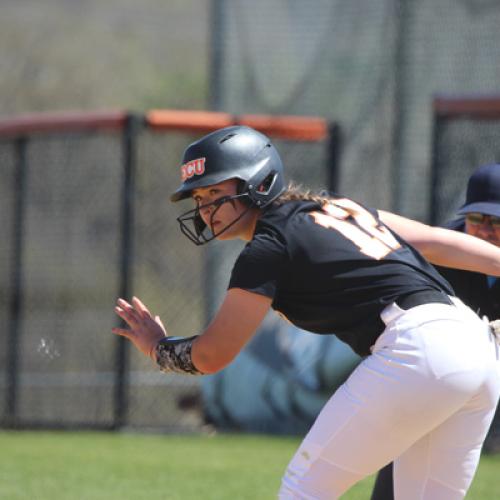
[458, 163, 500, 217]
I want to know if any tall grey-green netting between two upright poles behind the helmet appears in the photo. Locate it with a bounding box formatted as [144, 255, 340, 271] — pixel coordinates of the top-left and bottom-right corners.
[216, 0, 398, 213]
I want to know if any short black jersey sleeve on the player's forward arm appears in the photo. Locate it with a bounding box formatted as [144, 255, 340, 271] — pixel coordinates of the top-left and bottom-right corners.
[228, 229, 289, 298]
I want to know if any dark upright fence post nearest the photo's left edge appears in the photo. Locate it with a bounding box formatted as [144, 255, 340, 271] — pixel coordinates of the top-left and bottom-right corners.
[5, 137, 28, 427]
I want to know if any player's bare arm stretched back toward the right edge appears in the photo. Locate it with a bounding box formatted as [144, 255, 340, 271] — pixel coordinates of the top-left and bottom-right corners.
[378, 210, 500, 276]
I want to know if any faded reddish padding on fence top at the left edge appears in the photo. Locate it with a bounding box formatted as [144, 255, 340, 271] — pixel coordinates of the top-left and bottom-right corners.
[0, 111, 128, 136]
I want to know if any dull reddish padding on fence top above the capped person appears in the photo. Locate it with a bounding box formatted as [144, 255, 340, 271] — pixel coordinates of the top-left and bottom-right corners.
[433, 95, 500, 119]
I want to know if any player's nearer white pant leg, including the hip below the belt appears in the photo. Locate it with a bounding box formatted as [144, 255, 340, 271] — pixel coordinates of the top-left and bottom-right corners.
[280, 298, 499, 500]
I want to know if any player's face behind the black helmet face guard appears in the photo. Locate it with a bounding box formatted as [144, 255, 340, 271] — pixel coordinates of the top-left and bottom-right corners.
[191, 179, 256, 240]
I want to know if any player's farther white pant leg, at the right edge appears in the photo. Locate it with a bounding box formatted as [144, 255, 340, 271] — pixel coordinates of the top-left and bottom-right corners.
[394, 298, 500, 500]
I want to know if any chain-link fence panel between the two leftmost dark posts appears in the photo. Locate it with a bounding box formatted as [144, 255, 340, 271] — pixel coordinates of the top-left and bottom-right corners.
[11, 134, 122, 424]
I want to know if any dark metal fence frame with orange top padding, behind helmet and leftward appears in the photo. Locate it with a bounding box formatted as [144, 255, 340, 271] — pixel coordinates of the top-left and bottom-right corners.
[0, 110, 340, 430]
